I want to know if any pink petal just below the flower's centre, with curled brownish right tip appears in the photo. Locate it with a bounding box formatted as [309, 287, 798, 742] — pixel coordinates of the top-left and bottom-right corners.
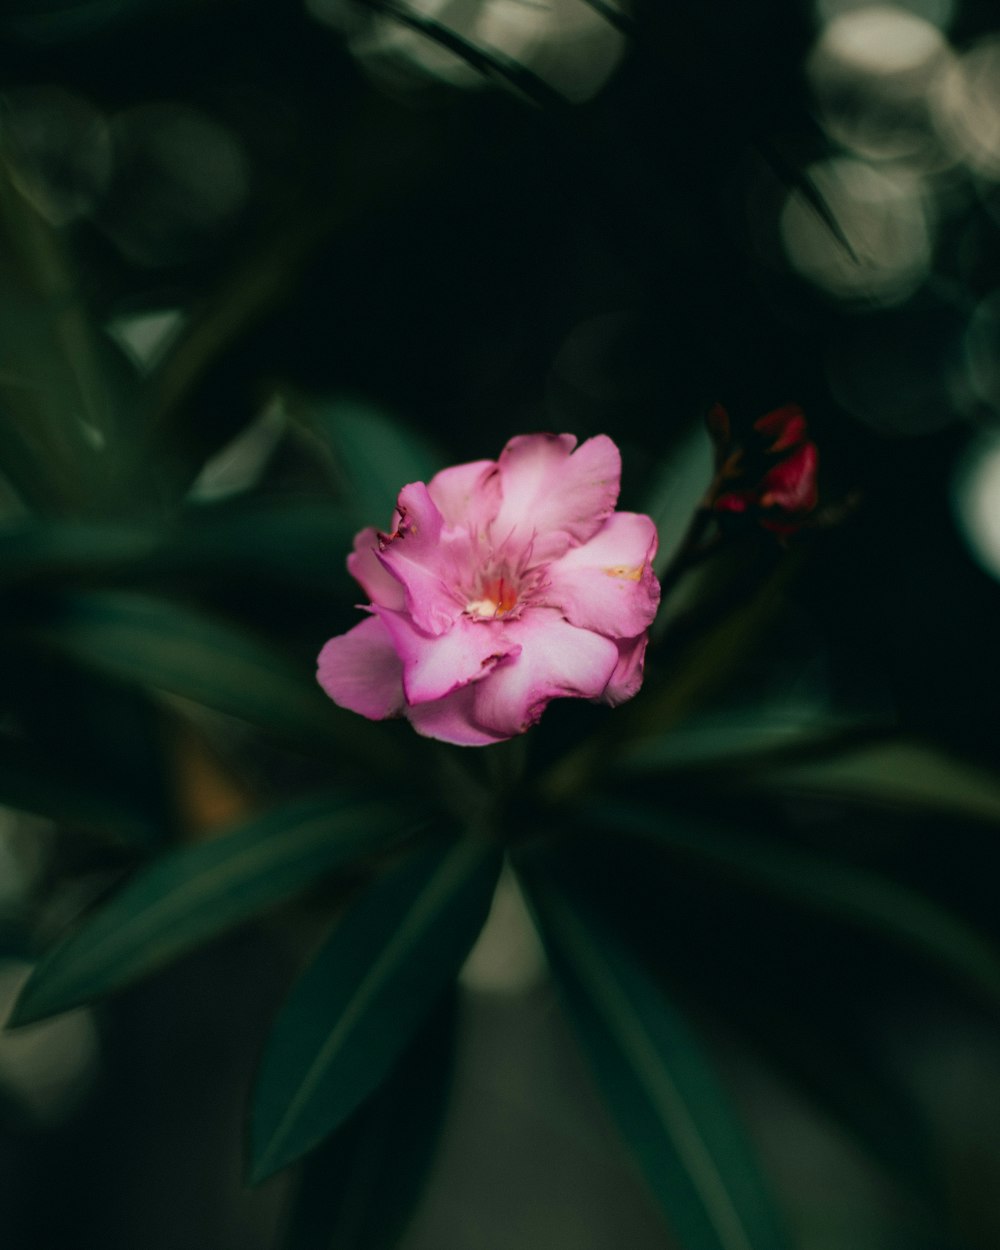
[381, 611, 520, 705]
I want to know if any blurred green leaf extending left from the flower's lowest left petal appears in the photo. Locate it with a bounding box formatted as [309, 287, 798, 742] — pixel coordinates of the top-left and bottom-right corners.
[30, 593, 390, 758]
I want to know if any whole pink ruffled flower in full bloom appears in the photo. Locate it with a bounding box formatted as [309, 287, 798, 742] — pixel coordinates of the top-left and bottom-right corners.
[318, 434, 660, 746]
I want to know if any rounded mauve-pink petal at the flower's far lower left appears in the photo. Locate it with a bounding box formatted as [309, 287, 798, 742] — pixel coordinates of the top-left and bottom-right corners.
[316, 616, 404, 720]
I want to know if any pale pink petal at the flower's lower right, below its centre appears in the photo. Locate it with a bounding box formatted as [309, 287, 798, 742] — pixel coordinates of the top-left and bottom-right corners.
[471, 608, 619, 738]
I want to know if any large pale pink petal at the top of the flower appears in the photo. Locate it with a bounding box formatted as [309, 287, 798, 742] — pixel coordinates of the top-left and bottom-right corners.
[493, 434, 621, 564]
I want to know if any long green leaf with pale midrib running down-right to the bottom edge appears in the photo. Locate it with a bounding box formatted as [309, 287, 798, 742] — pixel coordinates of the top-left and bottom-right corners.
[519, 861, 786, 1250]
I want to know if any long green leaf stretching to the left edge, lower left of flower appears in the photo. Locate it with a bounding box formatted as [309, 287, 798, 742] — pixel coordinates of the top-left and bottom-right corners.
[11, 794, 414, 1024]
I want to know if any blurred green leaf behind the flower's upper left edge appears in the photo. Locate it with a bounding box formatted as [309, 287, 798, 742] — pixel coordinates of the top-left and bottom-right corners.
[293, 400, 443, 529]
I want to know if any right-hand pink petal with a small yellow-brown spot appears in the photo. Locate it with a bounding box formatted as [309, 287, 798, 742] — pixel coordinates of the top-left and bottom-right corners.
[543, 513, 660, 638]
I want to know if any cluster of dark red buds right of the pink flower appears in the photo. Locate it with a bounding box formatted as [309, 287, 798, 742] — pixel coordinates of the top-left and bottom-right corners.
[708, 404, 819, 535]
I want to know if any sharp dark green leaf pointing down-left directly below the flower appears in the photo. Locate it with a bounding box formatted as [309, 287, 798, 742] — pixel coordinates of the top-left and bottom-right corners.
[251, 839, 500, 1181]
